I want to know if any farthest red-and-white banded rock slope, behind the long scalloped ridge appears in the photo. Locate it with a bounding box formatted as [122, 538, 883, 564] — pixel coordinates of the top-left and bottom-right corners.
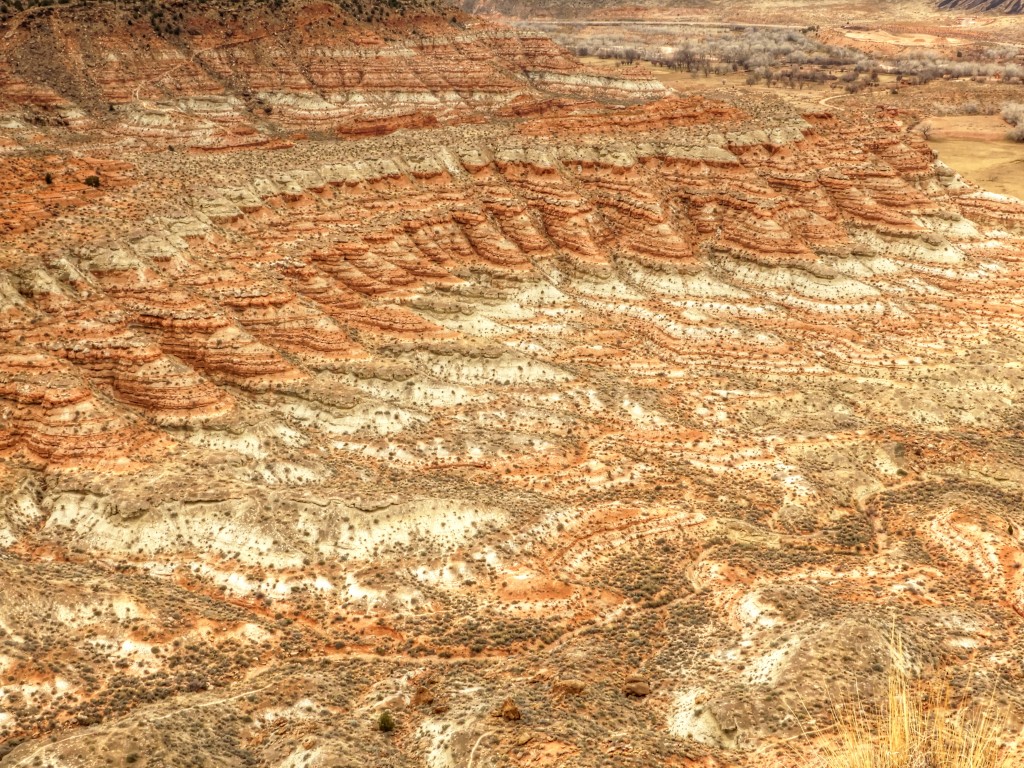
[0, 2, 664, 148]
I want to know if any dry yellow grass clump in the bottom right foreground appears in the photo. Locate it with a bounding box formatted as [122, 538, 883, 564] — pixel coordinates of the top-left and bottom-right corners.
[820, 637, 1011, 768]
